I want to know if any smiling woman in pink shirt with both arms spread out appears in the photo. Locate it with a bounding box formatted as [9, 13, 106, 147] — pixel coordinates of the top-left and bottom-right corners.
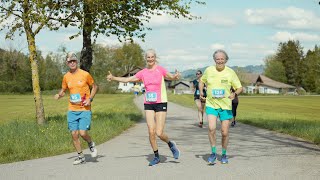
[107, 49, 180, 166]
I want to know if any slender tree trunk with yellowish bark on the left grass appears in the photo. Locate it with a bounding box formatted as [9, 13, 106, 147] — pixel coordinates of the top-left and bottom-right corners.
[26, 32, 46, 125]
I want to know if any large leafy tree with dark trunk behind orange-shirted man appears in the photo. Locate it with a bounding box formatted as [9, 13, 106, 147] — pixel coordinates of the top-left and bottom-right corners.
[64, 0, 204, 71]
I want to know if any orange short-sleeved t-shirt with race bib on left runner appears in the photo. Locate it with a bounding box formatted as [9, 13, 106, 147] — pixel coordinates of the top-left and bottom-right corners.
[62, 69, 94, 111]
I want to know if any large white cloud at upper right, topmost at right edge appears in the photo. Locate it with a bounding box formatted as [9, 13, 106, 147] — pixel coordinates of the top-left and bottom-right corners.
[245, 6, 320, 30]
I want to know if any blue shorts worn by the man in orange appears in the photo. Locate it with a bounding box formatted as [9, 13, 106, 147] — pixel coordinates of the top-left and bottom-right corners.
[67, 111, 92, 131]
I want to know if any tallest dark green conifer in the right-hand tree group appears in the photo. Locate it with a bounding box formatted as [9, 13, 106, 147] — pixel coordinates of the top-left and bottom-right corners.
[276, 40, 304, 87]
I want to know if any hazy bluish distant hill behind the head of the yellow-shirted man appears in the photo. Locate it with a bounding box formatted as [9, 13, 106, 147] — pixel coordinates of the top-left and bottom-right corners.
[181, 65, 264, 80]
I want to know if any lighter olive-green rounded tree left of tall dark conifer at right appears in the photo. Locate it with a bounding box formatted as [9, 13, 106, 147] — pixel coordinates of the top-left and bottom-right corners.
[264, 55, 287, 83]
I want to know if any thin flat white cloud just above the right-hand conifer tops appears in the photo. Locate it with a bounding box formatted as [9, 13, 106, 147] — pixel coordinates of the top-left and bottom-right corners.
[270, 31, 320, 42]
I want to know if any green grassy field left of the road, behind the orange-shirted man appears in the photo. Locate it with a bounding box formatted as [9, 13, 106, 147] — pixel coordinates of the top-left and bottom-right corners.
[0, 94, 142, 164]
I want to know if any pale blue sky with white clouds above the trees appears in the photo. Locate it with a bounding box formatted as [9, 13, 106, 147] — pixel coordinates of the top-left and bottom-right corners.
[0, 0, 320, 71]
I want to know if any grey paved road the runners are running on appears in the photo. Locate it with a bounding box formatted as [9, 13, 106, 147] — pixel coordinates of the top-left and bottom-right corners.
[0, 97, 320, 180]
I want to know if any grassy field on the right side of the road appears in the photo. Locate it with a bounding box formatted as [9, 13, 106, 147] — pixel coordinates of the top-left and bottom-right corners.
[168, 94, 320, 144]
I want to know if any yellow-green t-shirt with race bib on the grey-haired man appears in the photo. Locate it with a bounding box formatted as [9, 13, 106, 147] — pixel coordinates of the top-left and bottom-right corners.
[201, 66, 242, 110]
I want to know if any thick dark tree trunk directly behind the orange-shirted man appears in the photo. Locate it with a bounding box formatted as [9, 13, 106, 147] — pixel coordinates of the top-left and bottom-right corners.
[80, 0, 93, 72]
